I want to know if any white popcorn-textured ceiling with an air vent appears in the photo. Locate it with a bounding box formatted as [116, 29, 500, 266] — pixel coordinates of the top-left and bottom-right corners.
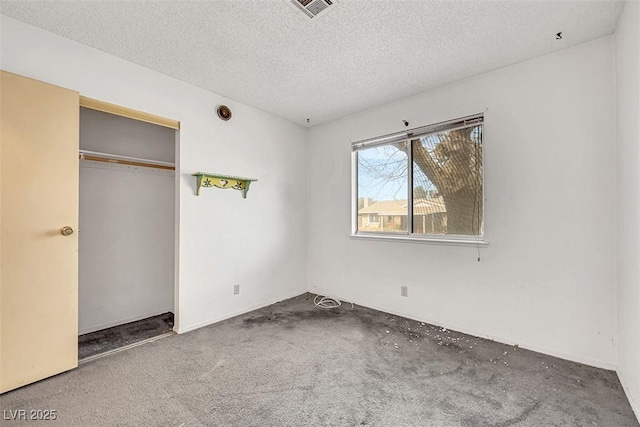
[0, 0, 623, 126]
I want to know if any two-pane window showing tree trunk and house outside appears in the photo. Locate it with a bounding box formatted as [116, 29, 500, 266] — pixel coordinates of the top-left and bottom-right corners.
[352, 115, 484, 242]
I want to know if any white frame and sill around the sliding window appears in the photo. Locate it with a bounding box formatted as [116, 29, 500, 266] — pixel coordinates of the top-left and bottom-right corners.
[351, 113, 488, 247]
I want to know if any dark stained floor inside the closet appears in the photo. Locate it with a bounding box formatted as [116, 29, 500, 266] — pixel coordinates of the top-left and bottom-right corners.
[78, 312, 173, 360]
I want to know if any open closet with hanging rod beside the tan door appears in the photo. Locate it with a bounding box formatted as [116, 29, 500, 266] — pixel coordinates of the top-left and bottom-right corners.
[78, 100, 178, 361]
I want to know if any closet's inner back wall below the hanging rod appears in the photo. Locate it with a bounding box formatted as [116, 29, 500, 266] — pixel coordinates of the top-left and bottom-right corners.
[78, 161, 175, 334]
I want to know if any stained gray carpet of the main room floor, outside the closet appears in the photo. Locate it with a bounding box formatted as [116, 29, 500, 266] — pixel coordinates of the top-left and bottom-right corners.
[0, 294, 638, 427]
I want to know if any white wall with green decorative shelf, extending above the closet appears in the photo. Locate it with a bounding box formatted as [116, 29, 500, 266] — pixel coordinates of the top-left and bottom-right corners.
[0, 16, 306, 331]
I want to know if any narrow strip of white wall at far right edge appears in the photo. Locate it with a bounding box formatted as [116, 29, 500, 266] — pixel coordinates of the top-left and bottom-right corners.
[616, 1, 640, 418]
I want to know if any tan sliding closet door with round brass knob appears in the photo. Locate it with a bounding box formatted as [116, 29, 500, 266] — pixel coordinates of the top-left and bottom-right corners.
[0, 71, 79, 393]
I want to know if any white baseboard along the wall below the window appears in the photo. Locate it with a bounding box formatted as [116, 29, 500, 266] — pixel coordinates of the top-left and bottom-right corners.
[309, 289, 617, 371]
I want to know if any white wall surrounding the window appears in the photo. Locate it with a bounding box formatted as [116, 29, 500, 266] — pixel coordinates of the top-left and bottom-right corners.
[308, 37, 616, 368]
